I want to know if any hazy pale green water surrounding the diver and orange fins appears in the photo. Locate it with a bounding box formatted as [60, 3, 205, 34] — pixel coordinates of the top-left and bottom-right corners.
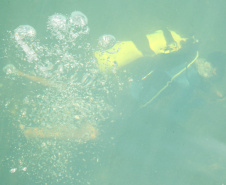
[0, 0, 226, 185]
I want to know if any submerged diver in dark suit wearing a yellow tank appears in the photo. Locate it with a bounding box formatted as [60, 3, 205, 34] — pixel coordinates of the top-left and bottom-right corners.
[95, 29, 225, 121]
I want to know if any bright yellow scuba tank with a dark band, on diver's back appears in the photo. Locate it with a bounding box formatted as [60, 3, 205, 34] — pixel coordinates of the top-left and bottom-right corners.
[94, 30, 187, 71]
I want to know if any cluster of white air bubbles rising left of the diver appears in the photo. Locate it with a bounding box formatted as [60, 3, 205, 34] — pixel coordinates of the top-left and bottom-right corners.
[3, 11, 122, 184]
